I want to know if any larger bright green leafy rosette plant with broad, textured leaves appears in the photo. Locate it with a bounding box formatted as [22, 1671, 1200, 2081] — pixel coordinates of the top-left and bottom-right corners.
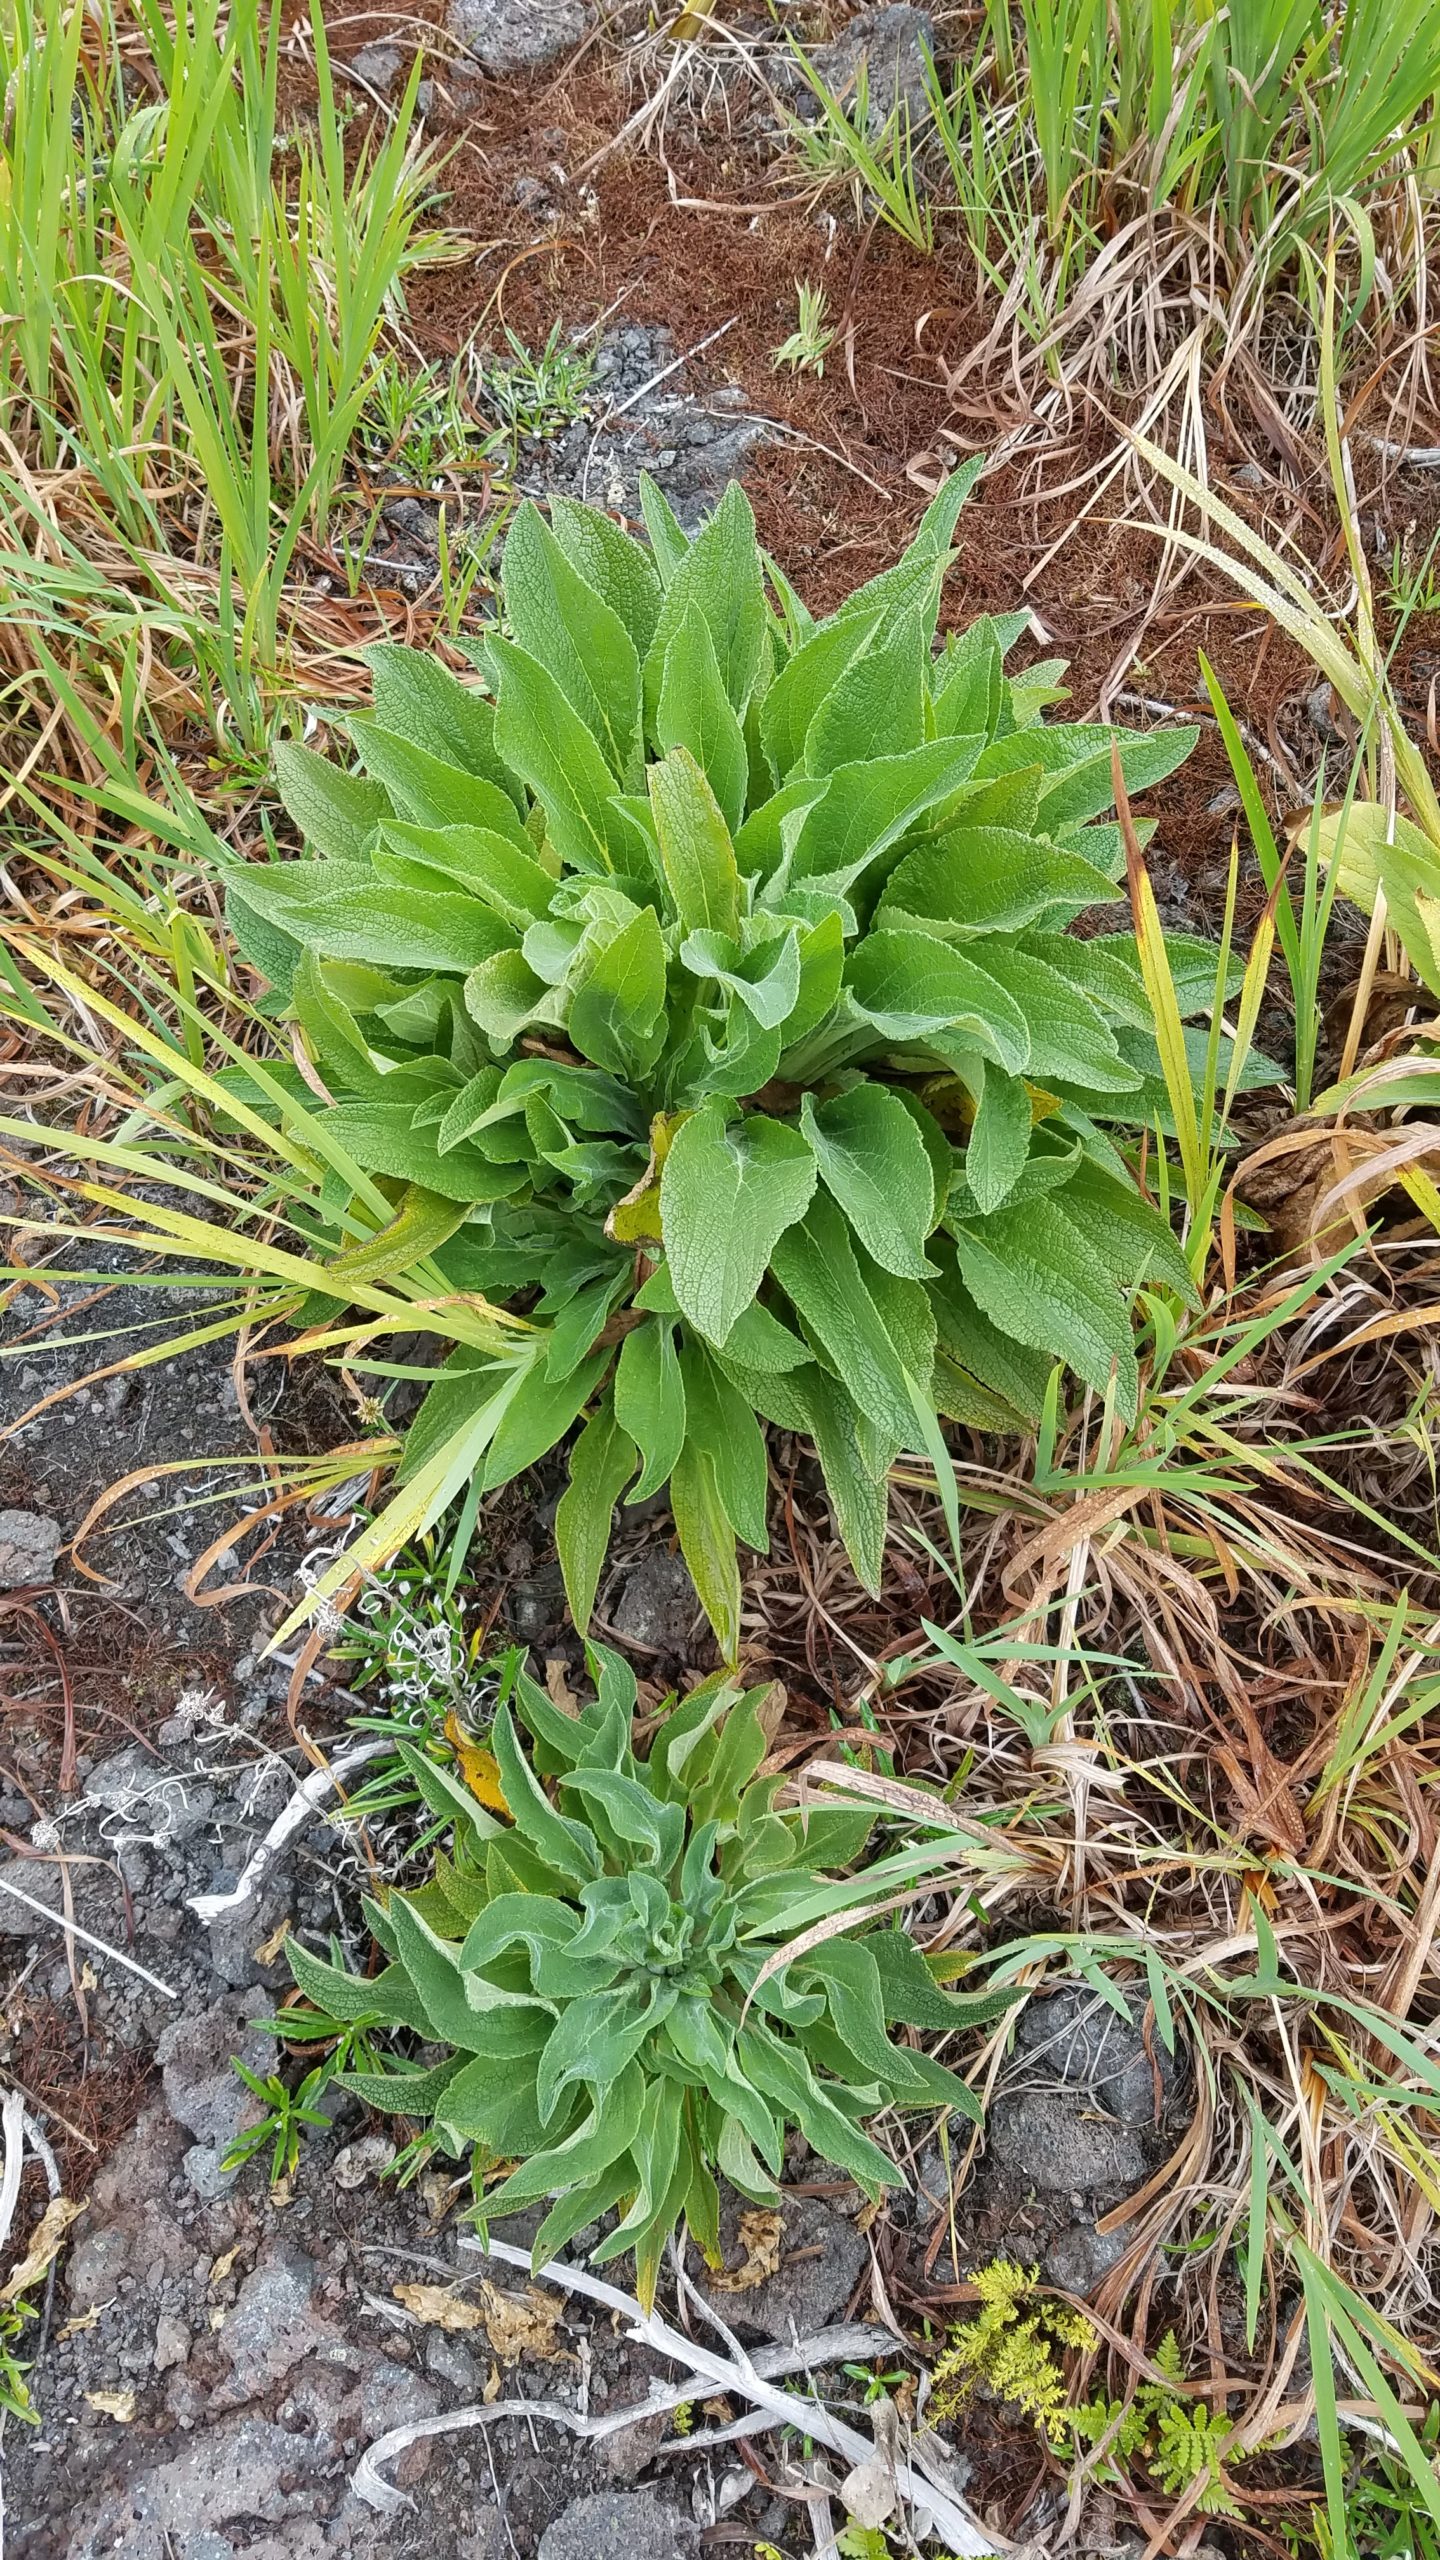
[228, 471, 1245, 1656]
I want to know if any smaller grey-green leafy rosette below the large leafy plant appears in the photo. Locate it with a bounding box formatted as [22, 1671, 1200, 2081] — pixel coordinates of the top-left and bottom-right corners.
[287, 1649, 1007, 2307]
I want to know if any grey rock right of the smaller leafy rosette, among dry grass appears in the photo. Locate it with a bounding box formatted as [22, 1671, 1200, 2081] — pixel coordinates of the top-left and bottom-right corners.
[989, 1987, 1176, 2196]
